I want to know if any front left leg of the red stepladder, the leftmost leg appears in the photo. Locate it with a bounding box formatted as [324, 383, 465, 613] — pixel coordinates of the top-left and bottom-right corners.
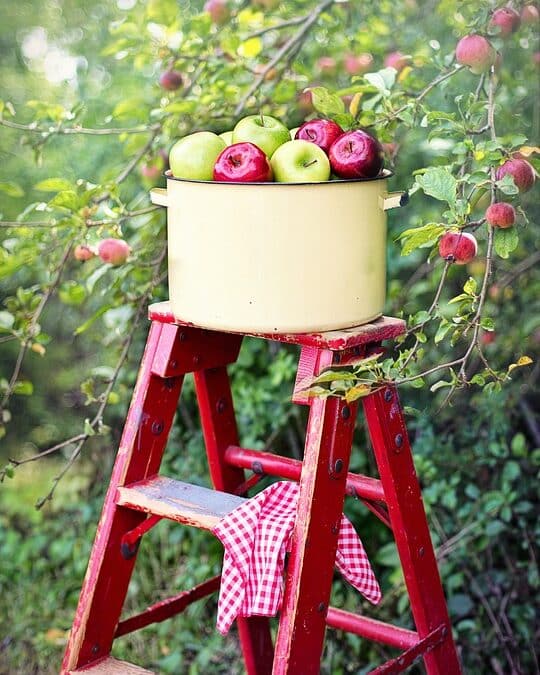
[61, 322, 183, 673]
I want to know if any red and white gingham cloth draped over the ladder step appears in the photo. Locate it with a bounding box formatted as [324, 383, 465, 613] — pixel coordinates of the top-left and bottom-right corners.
[213, 481, 381, 635]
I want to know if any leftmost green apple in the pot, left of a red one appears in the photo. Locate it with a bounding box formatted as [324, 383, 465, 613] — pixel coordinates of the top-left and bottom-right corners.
[169, 131, 227, 180]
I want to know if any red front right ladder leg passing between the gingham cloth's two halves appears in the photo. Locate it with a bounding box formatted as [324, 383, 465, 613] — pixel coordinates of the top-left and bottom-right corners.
[273, 350, 357, 675]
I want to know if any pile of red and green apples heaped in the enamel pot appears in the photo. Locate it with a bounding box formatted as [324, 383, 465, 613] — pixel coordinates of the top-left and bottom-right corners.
[169, 114, 383, 183]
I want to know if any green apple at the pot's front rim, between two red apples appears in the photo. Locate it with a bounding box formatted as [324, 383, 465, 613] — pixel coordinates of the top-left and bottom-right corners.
[270, 140, 330, 183]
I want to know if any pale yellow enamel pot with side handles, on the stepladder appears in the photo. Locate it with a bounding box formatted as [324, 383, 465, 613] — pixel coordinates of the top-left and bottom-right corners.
[150, 171, 407, 333]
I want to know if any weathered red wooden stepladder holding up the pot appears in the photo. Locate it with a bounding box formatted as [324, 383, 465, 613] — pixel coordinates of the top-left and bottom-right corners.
[61, 303, 461, 675]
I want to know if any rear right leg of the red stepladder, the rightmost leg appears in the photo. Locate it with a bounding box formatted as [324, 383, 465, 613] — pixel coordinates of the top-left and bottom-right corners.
[363, 386, 461, 675]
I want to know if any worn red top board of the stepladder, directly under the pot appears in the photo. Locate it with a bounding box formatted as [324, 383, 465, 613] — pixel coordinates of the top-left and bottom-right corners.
[148, 302, 405, 350]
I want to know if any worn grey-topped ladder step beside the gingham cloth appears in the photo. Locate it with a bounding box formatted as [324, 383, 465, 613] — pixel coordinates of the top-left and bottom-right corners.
[117, 476, 245, 530]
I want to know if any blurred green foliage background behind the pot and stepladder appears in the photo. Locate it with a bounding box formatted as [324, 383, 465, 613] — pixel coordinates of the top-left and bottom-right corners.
[0, 0, 540, 675]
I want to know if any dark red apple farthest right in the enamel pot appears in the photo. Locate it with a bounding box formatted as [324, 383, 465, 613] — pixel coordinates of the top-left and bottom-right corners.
[328, 129, 383, 178]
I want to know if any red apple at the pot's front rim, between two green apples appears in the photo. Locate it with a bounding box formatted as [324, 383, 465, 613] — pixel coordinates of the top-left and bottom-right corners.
[214, 143, 272, 183]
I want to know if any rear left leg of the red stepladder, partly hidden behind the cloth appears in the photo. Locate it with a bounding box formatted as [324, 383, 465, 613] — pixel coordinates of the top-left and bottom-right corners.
[194, 367, 274, 675]
